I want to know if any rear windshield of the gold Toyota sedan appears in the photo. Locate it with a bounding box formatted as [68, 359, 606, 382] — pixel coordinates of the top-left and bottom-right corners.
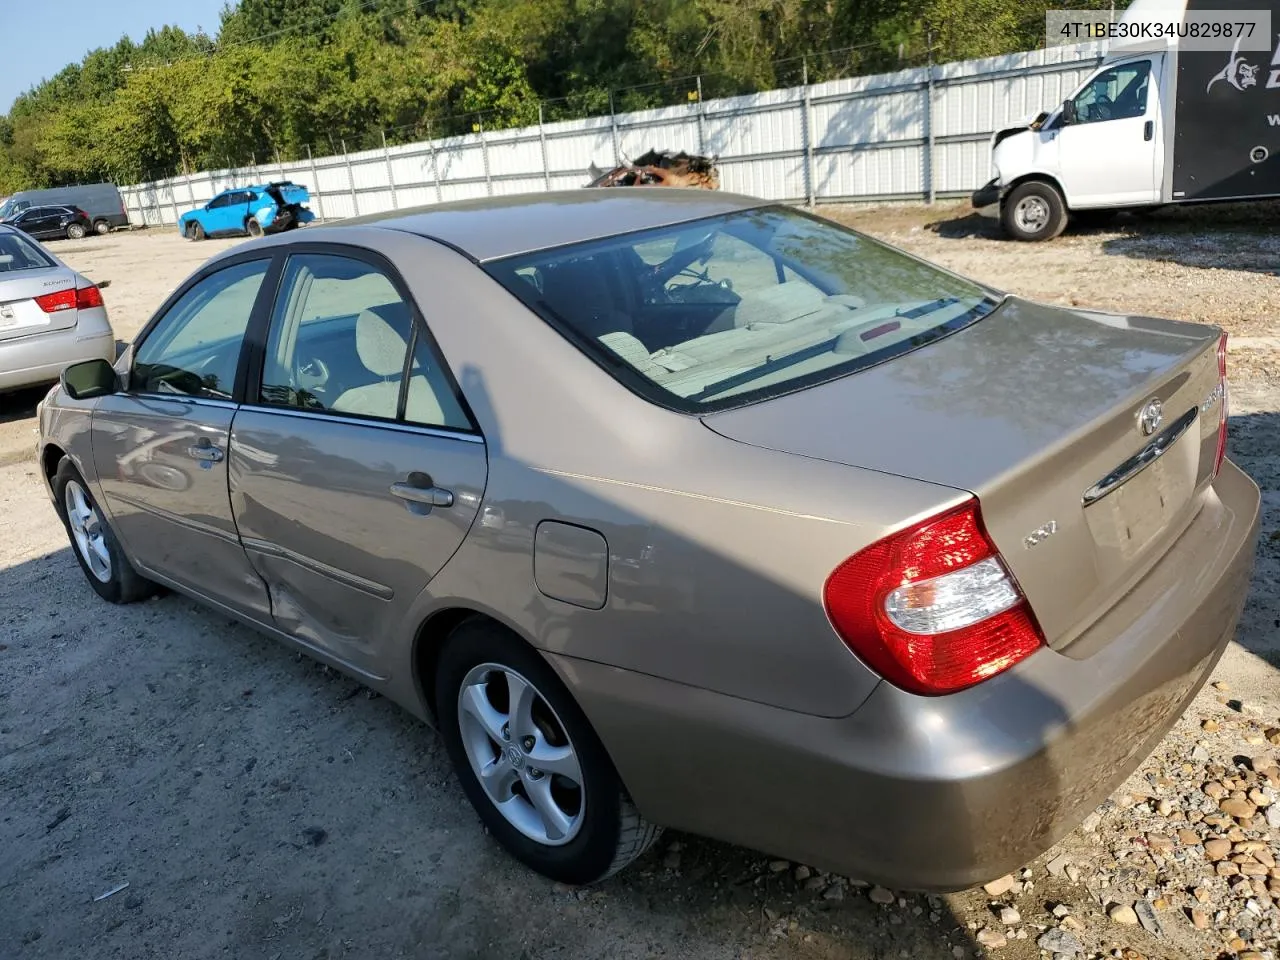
[485, 206, 998, 412]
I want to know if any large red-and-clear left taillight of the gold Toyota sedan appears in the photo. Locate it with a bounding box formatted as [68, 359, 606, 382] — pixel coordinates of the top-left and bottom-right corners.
[823, 499, 1044, 695]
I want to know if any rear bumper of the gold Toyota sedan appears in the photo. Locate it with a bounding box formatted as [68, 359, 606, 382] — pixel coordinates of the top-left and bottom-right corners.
[550, 462, 1260, 891]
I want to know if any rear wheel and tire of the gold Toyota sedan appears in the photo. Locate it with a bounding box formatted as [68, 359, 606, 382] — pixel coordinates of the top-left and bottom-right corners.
[435, 618, 662, 884]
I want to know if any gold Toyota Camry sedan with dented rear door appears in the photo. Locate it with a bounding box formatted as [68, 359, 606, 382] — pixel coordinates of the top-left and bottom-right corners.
[38, 189, 1260, 890]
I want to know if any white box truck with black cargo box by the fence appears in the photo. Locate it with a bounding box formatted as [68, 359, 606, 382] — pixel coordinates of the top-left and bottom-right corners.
[972, 0, 1280, 241]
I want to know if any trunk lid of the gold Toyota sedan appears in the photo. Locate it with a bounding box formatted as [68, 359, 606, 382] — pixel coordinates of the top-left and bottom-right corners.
[704, 297, 1225, 652]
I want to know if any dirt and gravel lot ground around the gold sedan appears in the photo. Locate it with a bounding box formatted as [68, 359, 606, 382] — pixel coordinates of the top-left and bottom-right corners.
[0, 205, 1280, 960]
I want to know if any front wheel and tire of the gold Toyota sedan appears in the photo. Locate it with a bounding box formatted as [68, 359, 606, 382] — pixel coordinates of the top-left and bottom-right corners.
[51, 457, 156, 603]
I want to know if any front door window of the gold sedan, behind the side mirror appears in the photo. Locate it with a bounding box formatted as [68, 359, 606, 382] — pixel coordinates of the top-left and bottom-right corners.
[129, 260, 270, 399]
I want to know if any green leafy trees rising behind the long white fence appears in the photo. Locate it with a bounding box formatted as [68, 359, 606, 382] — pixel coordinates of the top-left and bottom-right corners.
[0, 0, 1107, 195]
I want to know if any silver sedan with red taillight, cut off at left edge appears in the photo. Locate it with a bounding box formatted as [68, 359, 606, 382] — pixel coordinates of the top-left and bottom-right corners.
[0, 224, 115, 393]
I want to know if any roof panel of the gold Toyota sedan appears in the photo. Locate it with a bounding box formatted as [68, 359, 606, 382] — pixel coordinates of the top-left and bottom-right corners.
[320, 187, 773, 262]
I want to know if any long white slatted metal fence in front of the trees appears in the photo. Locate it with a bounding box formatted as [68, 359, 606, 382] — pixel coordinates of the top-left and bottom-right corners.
[122, 44, 1102, 225]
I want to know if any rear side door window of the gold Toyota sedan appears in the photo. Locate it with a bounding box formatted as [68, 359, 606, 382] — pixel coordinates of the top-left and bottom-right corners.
[259, 253, 471, 430]
